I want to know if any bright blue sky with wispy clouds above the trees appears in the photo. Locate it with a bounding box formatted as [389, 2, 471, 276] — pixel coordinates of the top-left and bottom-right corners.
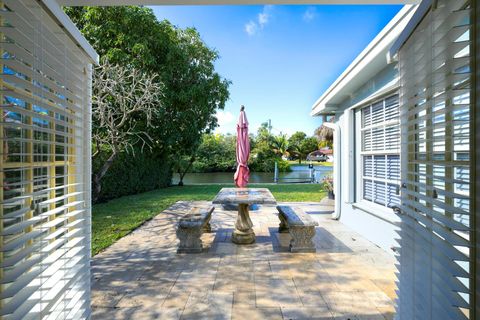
[152, 5, 401, 135]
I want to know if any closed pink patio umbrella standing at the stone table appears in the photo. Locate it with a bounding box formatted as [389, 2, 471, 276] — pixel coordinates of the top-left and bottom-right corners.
[233, 106, 250, 188]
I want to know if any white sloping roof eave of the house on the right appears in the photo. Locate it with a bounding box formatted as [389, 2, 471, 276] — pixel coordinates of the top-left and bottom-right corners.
[310, 5, 418, 116]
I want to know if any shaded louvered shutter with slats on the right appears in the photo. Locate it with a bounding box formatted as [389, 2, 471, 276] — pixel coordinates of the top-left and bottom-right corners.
[397, 0, 474, 320]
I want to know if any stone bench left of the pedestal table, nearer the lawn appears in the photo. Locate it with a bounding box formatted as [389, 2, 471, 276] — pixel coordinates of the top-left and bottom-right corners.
[177, 207, 215, 253]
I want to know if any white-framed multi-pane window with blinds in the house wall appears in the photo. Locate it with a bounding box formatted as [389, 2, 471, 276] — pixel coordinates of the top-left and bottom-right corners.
[357, 94, 400, 208]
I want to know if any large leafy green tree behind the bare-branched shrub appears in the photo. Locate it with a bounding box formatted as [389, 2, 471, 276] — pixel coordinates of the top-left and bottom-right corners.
[65, 6, 230, 189]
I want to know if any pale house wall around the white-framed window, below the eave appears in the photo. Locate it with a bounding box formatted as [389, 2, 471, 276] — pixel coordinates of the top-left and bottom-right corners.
[334, 64, 399, 254]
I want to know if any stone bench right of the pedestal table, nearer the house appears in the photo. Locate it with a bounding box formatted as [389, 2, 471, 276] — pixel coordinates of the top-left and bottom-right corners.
[277, 206, 318, 252]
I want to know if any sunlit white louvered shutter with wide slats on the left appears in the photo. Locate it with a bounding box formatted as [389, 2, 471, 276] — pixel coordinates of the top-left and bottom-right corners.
[0, 0, 91, 319]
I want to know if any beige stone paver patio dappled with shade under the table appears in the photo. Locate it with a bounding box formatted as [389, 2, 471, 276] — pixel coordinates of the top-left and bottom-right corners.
[92, 201, 395, 320]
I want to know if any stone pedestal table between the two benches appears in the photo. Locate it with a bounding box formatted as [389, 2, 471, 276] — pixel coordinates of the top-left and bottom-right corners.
[212, 188, 277, 244]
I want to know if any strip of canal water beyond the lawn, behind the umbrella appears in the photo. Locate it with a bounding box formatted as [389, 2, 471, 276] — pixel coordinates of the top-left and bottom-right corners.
[172, 165, 333, 184]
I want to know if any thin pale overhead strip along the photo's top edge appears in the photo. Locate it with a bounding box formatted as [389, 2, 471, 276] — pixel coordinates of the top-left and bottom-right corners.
[57, 0, 420, 6]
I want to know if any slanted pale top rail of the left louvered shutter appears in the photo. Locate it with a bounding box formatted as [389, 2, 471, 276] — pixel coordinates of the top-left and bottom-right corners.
[41, 0, 99, 64]
